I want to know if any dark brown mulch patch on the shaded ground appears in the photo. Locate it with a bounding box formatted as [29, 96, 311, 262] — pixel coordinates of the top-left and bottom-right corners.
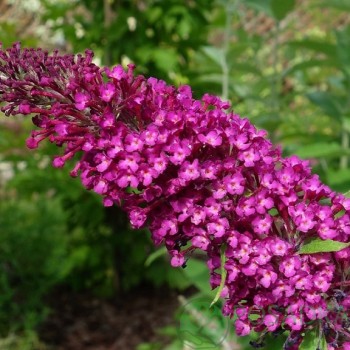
[39, 288, 178, 350]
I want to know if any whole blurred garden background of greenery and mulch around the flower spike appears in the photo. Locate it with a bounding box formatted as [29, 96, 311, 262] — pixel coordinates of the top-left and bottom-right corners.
[0, 0, 350, 350]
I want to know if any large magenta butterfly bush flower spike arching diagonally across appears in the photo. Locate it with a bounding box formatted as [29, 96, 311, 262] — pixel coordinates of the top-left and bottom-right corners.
[0, 44, 350, 349]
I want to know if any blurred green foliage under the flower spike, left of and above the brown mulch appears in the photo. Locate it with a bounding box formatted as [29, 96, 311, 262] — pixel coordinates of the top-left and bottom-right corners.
[0, 120, 190, 334]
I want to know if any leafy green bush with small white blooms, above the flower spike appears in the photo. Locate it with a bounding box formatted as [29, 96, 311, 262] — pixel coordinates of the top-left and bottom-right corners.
[43, 0, 214, 81]
